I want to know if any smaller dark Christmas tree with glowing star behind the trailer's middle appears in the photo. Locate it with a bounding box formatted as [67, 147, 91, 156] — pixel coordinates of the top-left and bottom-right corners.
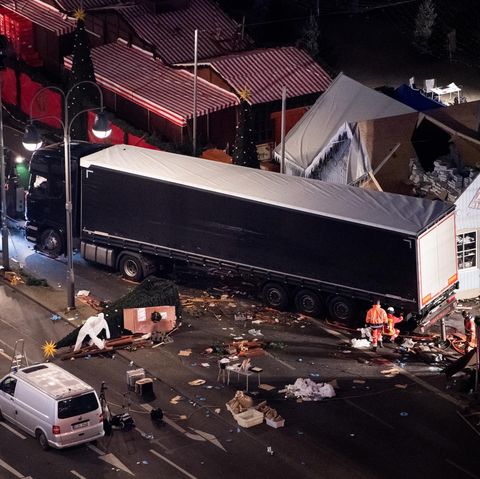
[232, 88, 260, 168]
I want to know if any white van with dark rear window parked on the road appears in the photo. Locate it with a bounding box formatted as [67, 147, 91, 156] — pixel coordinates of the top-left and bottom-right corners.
[0, 363, 104, 449]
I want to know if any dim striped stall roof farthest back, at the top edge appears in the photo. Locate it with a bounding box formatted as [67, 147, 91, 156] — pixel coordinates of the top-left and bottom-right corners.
[117, 0, 249, 65]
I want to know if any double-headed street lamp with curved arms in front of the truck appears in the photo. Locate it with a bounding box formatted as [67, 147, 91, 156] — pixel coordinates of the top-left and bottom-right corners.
[23, 80, 112, 310]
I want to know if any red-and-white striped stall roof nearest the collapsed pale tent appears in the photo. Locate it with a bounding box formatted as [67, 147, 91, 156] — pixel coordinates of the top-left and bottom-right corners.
[193, 47, 332, 104]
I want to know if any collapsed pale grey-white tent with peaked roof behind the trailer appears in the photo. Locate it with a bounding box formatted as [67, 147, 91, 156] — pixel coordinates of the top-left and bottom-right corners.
[274, 73, 415, 184]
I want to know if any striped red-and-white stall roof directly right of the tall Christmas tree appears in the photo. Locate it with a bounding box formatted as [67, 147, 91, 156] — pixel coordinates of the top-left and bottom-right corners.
[64, 40, 238, 126]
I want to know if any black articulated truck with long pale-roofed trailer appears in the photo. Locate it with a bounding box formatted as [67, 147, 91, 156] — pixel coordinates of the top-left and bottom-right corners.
[26, 143, 458, 326]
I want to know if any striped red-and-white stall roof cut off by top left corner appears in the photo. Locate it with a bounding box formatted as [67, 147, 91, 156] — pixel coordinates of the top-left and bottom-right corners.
[0, 0, 75, 36]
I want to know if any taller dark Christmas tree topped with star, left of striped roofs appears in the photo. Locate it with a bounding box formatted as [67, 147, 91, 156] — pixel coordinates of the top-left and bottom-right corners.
[68, 8, 100, 141]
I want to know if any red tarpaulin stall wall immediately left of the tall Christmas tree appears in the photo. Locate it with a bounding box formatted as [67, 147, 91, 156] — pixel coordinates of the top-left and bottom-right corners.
[20, 73, 63, 128]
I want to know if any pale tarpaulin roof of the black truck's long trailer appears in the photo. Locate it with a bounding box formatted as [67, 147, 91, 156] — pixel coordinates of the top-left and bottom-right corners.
[80, 145, 454, 235]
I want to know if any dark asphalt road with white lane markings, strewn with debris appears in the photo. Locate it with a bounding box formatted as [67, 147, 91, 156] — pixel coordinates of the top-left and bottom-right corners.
[0, 237, 480, 479]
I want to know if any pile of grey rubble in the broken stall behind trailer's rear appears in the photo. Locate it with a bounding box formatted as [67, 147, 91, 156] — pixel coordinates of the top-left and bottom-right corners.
[410, 158, 478, 203]
